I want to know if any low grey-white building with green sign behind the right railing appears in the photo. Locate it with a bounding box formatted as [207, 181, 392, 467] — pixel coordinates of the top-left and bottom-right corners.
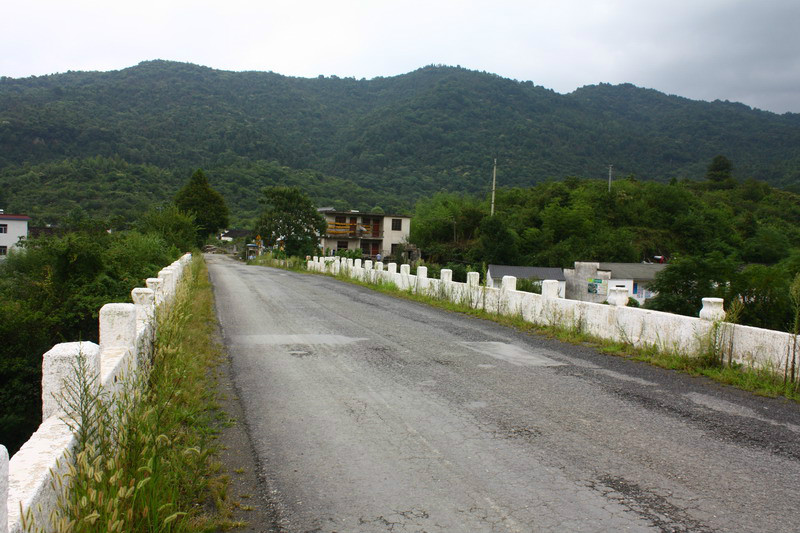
[564, 261, 667, 304]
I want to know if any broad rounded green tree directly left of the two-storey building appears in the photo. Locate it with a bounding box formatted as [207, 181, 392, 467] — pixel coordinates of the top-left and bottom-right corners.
[257, 187, 326, 256]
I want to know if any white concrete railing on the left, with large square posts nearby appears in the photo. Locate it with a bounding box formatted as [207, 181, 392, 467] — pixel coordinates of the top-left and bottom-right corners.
[0, 254, 192, 533]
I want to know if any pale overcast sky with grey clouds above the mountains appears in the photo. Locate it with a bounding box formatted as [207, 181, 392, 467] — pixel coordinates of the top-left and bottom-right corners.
[0, 0, 800, 113]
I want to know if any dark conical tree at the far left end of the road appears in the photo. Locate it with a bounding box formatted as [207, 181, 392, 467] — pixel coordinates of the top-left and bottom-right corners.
[175, 169, 228, 245]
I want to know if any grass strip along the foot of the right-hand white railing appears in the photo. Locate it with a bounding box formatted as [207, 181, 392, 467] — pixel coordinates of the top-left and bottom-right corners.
[262, 256, 800, 402]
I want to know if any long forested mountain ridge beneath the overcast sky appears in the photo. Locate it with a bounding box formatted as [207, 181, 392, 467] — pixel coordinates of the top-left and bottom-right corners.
[0, 61, 800, 222]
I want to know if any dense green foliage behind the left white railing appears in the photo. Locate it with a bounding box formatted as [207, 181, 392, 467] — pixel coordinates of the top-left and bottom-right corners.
[0, 221, 177, 453]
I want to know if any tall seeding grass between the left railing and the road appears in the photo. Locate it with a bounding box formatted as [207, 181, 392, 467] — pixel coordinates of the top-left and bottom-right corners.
[25, 257, 235, 533]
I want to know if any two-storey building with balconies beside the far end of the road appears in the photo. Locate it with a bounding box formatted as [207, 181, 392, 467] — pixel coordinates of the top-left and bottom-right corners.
[319, 207, 411, 258]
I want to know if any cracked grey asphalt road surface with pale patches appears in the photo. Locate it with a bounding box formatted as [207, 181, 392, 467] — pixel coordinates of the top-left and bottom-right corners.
[207, 256, 800, 533]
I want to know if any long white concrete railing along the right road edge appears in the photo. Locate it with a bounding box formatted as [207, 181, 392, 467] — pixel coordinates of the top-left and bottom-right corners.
[307, 257, 798, 371]
